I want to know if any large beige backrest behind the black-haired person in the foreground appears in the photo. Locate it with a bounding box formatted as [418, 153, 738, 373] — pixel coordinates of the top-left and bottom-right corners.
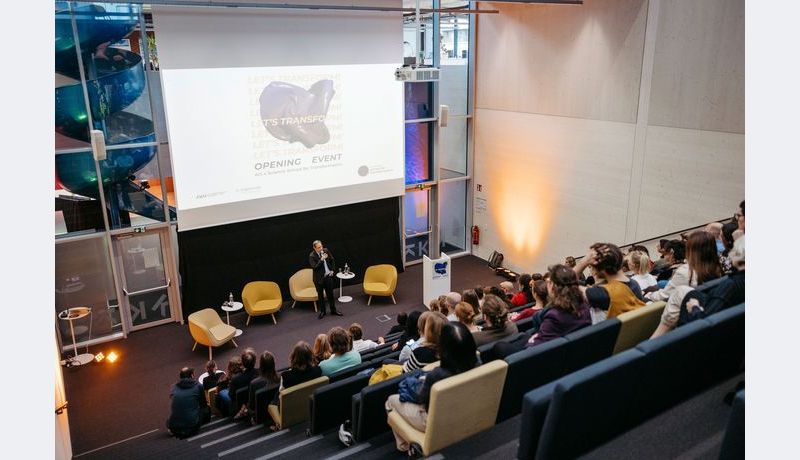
[423, 360, 508, 453]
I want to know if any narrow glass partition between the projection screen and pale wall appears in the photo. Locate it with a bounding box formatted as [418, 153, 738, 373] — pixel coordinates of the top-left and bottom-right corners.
[402, 0, 475, 265]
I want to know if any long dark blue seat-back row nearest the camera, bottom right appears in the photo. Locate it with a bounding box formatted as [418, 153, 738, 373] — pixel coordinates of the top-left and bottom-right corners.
[517, 304, 745, 459]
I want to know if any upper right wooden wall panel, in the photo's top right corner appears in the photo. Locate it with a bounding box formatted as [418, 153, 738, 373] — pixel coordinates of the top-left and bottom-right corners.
[649, 0, 745, 134]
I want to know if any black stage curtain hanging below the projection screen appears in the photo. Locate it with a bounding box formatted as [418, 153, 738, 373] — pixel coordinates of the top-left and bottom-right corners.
[178, 198, 403, 318]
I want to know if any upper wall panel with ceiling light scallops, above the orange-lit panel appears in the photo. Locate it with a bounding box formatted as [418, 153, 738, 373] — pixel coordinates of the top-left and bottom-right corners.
[476, 0, 647, 123]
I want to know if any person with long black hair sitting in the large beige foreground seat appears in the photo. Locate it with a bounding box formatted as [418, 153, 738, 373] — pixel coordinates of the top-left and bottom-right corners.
[386, 324, 477, 452]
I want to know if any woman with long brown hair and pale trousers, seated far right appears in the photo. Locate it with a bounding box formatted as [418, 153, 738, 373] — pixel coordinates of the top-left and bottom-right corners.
[653, 231, 722, 337]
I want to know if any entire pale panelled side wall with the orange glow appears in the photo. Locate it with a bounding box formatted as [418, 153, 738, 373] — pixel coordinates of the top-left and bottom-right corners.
[473, 0, 744, 271]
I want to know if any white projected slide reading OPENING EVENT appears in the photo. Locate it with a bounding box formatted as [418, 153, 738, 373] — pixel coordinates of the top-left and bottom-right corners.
[161, 64, 404, 229]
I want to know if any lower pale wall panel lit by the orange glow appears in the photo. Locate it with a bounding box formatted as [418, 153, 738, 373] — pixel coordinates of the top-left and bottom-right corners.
[473, 109, 635, 271]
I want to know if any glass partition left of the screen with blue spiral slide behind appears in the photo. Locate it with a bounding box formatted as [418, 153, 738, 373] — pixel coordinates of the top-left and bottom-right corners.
[54, 1, 181, 357]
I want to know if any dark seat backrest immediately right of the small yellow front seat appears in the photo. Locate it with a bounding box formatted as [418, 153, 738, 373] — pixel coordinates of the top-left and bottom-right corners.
[311, 375, 369, 434]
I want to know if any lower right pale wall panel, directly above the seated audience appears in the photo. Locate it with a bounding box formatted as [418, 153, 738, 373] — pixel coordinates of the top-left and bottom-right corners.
[636, 126, 745, 240]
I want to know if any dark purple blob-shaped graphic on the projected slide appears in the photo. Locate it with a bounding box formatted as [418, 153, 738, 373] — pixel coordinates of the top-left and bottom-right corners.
[259, 80, 336, 149]
